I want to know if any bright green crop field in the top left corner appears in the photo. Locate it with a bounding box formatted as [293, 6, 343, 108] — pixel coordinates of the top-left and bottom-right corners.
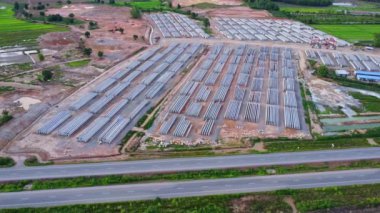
[0, 3, 67, 47]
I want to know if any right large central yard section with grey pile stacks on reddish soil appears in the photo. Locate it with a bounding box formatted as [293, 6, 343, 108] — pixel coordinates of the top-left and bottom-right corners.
[155, 45, 308, 144]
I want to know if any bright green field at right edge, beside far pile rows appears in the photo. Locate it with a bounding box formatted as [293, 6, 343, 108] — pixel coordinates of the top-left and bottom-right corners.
[312, 24, 380, 43]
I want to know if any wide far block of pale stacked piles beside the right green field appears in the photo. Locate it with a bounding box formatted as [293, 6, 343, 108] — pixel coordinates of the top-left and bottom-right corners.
[215, 18, 349, 46]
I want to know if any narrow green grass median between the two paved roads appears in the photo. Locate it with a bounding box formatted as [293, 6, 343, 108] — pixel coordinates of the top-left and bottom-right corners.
[0, 160, 380, 192]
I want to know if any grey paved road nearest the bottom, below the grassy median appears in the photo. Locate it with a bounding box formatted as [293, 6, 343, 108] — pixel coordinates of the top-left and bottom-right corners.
[0, 169, 380, 208]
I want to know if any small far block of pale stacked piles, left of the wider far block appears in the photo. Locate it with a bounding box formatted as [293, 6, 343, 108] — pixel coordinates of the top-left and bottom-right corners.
[149, 13, 209, 38]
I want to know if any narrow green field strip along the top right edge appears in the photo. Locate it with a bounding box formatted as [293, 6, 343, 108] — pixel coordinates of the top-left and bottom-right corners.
[276, 1, 380, 13]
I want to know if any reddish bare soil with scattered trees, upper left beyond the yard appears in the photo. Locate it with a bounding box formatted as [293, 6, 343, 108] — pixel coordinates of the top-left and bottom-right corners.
[44, 4, 150, 65]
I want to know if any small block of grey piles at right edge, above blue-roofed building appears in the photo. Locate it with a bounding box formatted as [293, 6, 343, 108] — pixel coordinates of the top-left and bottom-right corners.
[305, 50, 380, 72]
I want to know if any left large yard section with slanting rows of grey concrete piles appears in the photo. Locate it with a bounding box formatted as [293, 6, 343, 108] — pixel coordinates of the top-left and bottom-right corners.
[8, 44, 203, 159]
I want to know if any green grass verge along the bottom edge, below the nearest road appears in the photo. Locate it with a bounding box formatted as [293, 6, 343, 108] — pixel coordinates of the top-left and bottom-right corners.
[4, 184, 380, 213]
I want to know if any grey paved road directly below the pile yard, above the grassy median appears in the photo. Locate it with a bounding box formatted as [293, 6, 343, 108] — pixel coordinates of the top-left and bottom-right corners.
[0, 148, 380, 182]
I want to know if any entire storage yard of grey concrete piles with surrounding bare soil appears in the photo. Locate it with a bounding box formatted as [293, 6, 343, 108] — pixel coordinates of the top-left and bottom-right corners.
[0, 1, 380, 160]
